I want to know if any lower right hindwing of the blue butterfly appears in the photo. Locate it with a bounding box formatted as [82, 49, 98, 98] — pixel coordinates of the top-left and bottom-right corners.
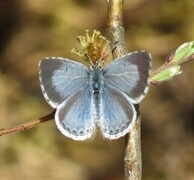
[100, 84, 137, 139]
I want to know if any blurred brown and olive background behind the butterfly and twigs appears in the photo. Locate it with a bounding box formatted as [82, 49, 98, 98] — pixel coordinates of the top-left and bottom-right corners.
[0, 0, 194, 180]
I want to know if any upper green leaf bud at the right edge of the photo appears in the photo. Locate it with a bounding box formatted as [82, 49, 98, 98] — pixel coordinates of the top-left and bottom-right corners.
[172, 41, 194, 62]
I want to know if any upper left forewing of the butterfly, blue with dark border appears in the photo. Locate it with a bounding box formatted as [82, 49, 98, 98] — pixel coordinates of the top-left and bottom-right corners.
[39, 57, 89, 108]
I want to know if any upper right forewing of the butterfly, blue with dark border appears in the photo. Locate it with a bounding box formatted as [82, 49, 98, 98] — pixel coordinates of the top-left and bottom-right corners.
[104, 52, 151, 104]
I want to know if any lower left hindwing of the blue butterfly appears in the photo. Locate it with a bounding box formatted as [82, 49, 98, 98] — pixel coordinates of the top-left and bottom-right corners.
[55, 86, 95, 140]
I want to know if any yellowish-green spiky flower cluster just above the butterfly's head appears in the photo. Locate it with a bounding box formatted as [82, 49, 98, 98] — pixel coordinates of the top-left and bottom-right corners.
[72, 30, 110, 69]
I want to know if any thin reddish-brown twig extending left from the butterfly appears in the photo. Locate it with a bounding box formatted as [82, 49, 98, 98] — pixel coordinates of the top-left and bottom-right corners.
[0, 110, 55, 136]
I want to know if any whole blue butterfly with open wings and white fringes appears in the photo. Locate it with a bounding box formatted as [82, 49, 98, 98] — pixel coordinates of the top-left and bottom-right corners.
[39, 51, 151, 140]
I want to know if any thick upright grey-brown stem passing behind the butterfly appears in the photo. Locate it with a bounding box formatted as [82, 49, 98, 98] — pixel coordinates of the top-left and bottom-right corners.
[107, 0, 142, 180]
